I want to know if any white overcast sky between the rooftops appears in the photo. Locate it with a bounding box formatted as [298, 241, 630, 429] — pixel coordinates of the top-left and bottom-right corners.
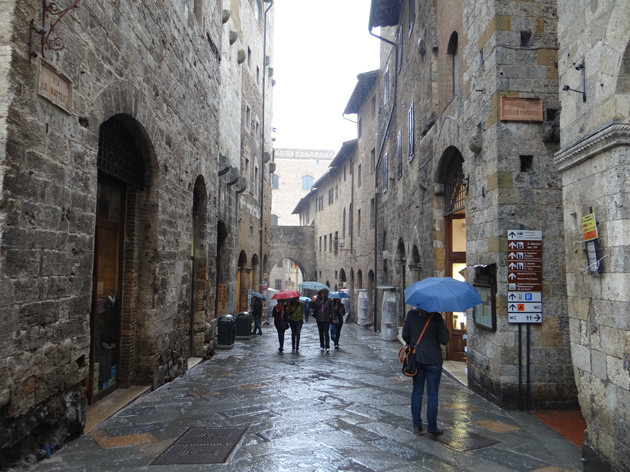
[273, 0, 380, 151]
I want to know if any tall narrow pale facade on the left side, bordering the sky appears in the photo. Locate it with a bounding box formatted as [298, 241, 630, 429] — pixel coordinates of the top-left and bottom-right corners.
[217, 0, 274, 314]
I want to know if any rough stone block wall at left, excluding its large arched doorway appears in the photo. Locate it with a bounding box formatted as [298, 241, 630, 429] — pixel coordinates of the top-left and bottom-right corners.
[0, 0, 237, 465]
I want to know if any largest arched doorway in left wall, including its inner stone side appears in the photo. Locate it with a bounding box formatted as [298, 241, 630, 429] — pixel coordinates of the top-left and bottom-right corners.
[88, 114, 157, 403]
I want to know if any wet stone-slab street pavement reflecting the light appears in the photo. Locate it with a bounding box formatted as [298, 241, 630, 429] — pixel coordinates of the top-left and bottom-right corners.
[29, 319, 582, 472]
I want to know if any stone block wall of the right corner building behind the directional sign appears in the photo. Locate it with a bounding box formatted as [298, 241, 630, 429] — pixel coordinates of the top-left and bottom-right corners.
[376, 1, 576, 408]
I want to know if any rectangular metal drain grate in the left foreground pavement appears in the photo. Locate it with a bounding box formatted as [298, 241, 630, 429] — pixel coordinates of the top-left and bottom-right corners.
[151, 428, 247, 465]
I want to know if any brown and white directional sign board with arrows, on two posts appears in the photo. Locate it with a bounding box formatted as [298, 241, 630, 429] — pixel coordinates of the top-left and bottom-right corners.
[508, 230, 542, 323]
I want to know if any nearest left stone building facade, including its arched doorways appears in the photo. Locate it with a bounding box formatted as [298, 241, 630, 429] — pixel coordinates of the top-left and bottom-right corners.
[0, 0, 271, 466]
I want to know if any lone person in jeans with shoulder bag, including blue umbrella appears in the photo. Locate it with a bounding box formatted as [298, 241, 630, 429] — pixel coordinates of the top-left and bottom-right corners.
[402, 277, 481, 435]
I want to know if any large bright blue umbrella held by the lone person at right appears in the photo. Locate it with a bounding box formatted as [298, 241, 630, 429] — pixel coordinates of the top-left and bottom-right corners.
[405, 277, 482, 313]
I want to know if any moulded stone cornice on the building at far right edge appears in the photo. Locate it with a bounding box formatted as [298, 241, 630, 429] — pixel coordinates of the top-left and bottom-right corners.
[554, 120, 630, 171]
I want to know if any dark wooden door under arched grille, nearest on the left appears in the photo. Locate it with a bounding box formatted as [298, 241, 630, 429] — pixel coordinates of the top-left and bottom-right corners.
[88, 115, 144, 404]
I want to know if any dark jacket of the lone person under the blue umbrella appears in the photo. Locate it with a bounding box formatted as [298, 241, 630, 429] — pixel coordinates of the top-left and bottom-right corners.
[402, 309, 449, 365]
